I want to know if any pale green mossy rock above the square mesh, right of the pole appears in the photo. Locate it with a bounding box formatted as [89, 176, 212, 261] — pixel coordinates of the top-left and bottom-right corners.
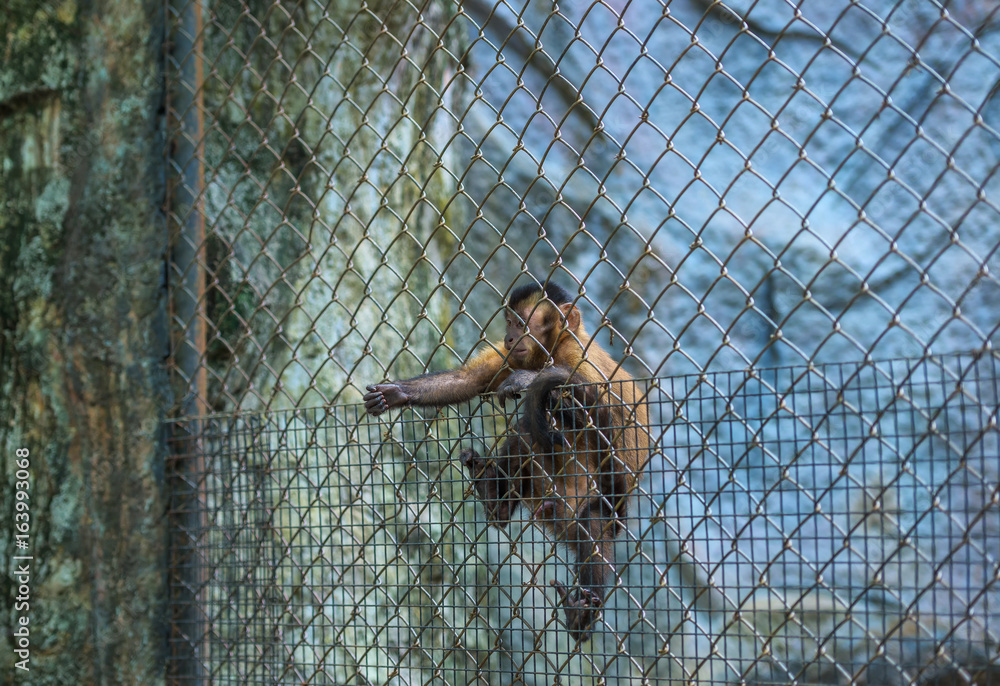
[193, 2, 475, 412]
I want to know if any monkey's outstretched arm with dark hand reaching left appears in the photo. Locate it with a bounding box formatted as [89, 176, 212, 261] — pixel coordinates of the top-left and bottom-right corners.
[364, 343, 510, 415]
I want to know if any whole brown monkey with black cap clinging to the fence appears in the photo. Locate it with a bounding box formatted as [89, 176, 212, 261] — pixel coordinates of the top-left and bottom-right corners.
[364, 282, 649, 640]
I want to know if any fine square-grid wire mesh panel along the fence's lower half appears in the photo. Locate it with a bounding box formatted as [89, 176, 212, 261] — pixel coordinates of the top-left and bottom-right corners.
[172, 354, 1000, 684]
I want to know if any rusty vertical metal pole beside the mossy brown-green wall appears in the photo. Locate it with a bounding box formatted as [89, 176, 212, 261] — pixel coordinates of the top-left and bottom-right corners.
[167, 0, 210, 686]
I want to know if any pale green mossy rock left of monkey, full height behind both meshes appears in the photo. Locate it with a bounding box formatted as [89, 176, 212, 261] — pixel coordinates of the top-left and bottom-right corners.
[182, 1, 495, 683]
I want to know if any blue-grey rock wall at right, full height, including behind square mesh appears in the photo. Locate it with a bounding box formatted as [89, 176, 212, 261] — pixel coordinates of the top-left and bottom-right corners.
[454, 0, 1000, 683]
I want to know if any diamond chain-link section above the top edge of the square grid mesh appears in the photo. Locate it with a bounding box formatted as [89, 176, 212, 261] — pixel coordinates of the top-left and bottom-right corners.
[167, 0, 1000, 411]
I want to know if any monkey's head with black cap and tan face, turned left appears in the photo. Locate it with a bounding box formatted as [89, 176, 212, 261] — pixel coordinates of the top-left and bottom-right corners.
[504, 283, 585, 369]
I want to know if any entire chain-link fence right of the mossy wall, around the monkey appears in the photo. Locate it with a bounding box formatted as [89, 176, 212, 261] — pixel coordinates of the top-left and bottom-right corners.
[167, 0, 1000, 684]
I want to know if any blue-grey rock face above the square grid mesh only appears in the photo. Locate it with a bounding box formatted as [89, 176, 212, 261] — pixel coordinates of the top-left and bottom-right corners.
[464, 0, 1000, 375]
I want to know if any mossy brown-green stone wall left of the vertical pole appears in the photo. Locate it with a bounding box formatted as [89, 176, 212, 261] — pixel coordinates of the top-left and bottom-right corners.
[0, 0, 170, 686]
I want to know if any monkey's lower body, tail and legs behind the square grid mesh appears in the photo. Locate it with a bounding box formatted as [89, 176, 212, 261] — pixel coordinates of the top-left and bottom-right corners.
[459, 367, 648, 640]
